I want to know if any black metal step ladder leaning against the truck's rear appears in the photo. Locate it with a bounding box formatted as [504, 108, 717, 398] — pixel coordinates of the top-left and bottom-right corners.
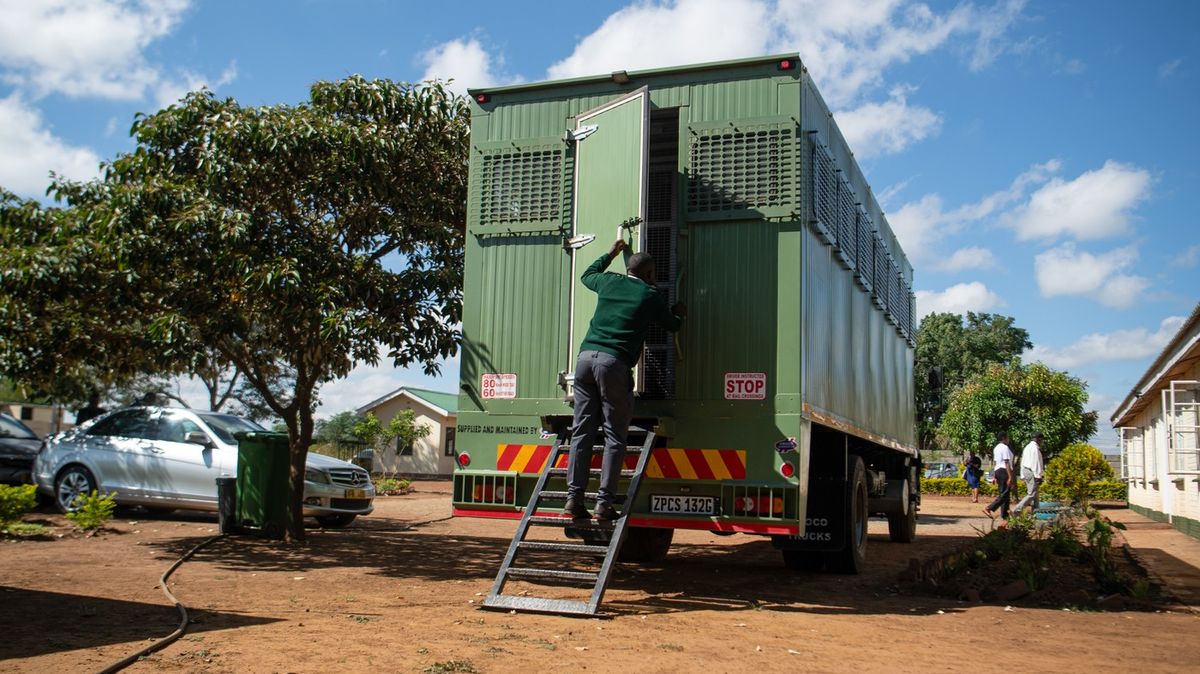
[482, 427, 655, 615]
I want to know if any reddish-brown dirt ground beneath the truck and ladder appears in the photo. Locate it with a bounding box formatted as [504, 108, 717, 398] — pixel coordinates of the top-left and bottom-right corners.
[0, 483, 1200, 673]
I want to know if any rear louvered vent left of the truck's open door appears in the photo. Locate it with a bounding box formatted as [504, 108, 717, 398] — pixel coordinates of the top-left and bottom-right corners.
[479, 146, 563, 227]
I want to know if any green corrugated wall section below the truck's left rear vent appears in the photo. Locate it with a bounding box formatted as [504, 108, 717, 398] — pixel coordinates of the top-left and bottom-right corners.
[462, 235, 569, 398]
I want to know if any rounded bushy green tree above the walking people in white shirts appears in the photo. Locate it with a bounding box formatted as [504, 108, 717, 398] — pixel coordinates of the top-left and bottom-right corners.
[938, 360, 1097, 461]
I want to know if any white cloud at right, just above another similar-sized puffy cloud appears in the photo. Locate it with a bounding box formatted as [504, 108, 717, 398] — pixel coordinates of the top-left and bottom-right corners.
[1006, 160, 1151, 241]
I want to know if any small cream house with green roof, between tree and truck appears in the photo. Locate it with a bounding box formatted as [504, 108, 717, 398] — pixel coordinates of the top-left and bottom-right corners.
[354, 386, 458, 477]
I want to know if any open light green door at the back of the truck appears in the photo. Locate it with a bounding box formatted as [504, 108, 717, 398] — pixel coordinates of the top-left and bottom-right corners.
[566, 86, 650, 386]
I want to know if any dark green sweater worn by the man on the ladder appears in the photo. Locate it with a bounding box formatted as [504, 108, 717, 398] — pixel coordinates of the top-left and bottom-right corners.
[580, 253, 683, 367]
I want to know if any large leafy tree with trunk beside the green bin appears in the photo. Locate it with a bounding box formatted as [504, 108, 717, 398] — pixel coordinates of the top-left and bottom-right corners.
[0, 77, 468, 540]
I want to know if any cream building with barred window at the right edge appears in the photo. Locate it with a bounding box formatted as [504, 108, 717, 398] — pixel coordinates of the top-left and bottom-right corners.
[1112, 305, 1200, 538]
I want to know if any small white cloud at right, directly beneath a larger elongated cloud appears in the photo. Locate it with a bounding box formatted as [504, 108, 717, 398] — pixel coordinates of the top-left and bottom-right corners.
[1033, 243, 1150, 309]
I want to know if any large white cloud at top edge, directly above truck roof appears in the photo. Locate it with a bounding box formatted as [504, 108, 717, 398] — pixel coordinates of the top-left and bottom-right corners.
[548, 0, 1025, 108]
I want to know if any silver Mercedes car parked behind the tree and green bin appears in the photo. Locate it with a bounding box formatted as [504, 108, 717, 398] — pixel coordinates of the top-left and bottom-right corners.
[34, 407, 374, 526]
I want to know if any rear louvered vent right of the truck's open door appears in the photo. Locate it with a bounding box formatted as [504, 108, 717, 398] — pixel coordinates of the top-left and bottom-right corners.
[686, 124, 799, 215]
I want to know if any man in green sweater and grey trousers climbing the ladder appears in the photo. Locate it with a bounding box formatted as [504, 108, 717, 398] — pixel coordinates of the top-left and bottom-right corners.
[564, 239, 688, 520]
